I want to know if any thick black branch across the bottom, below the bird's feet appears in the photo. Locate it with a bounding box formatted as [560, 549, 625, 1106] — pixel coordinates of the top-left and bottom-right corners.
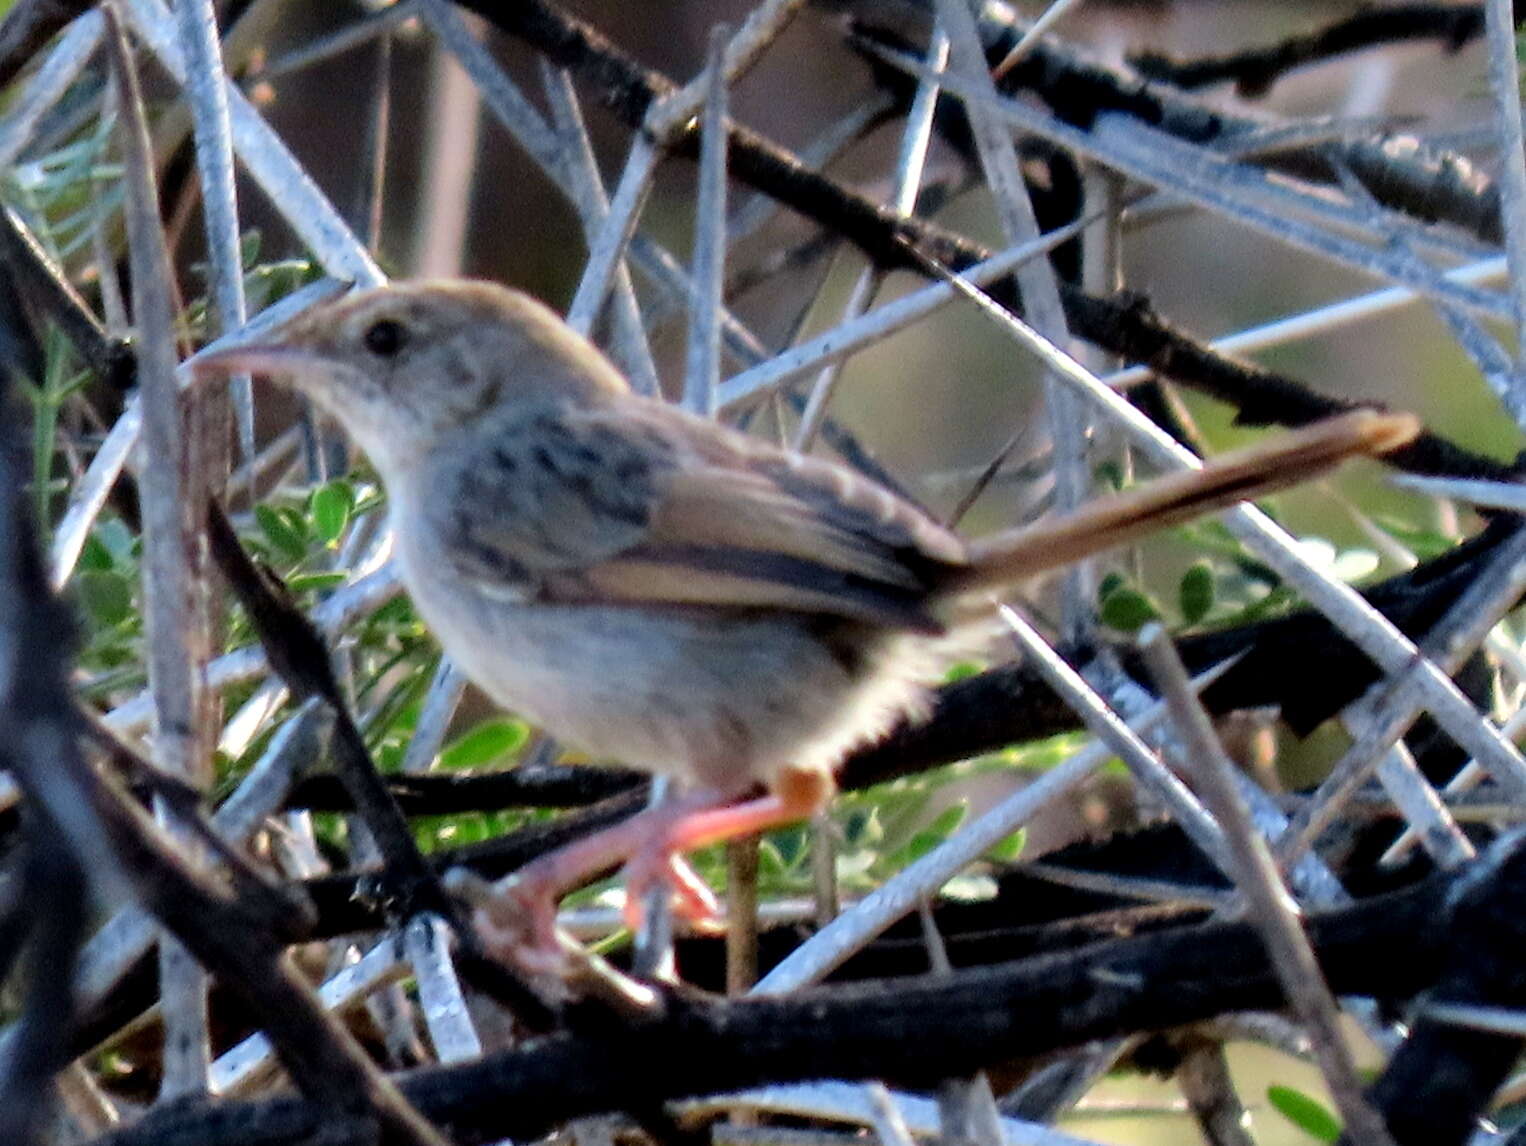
[89, 838, 1526, 1146]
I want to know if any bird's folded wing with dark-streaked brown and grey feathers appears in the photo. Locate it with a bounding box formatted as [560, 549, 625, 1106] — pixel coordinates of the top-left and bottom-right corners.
[439, 403, 963, 630]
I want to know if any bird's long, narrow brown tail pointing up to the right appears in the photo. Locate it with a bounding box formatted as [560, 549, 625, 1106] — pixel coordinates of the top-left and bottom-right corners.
[949, 410, 1421, 592]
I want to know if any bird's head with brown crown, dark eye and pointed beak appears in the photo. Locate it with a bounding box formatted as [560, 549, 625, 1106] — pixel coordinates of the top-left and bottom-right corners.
[192, 281, 627, 478]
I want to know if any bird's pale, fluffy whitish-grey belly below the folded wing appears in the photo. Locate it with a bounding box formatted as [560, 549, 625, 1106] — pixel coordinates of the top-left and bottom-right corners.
[398, 527, 925, 792]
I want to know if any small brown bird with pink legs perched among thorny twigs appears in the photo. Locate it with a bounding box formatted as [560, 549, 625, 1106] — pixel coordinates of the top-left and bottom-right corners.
[197, 282, 1418, 949]
